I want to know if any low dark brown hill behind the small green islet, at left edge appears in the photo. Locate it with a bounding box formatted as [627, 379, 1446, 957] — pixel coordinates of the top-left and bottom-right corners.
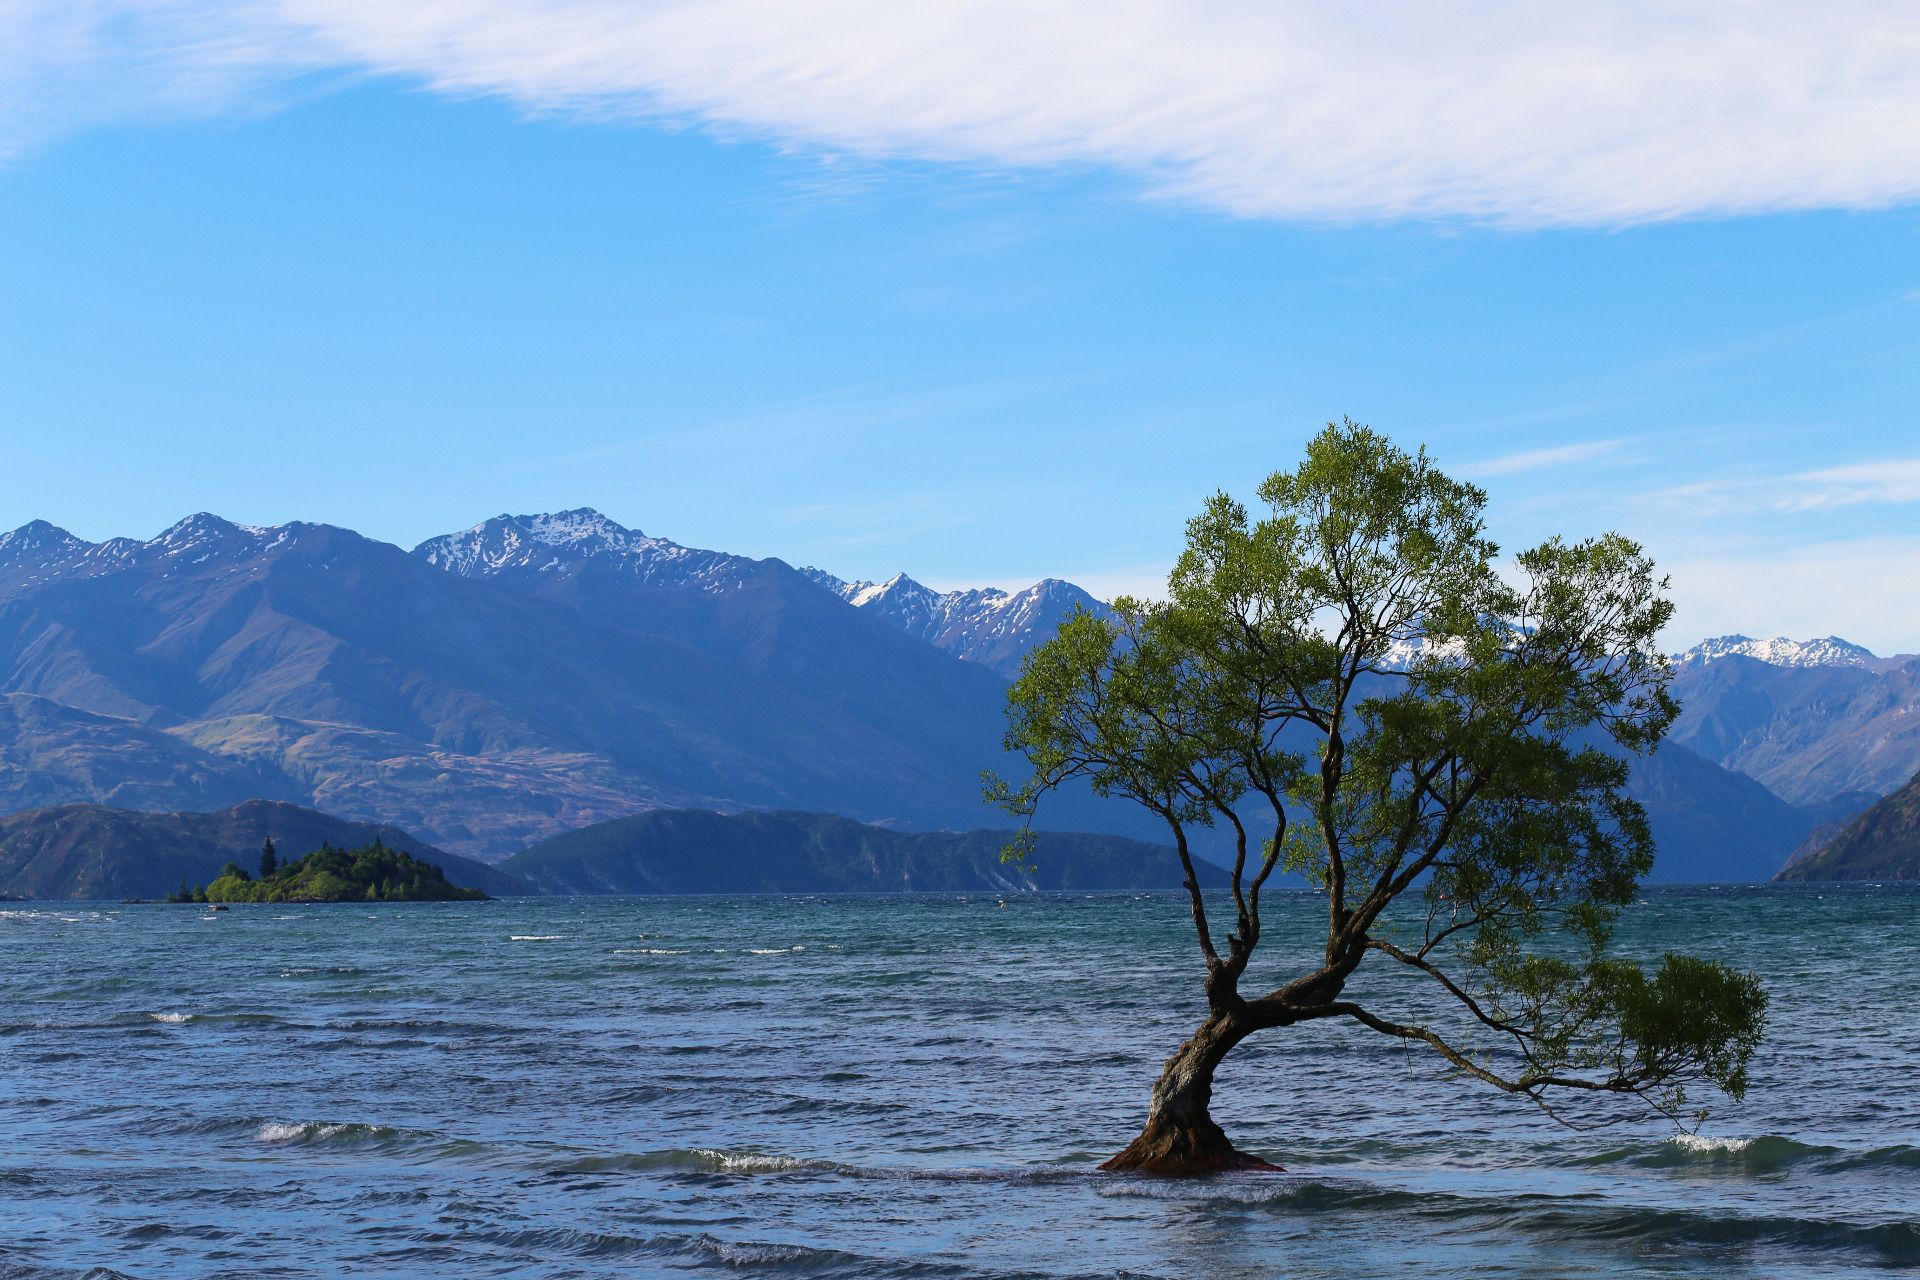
[0, 800, 526, 900]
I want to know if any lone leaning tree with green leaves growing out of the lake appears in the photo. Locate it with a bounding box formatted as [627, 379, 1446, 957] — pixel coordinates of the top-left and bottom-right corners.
[991, 422, 1766, 1174]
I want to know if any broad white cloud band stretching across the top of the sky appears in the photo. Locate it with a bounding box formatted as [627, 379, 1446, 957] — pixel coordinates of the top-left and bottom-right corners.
[0, 0, 1920, 226]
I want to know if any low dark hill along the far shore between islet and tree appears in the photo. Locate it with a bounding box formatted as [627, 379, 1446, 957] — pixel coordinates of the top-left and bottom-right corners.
[501, 810, 1225, 894]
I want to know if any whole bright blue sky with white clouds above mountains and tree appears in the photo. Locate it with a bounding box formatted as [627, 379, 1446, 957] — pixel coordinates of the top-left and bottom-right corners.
[0, 0, 1920, 652]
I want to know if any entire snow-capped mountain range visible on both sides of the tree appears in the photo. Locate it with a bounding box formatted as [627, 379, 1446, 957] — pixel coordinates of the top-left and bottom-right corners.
[0, 509, 1920, 879]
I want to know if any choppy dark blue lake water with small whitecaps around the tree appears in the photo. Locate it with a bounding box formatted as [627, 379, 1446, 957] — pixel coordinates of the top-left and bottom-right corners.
[0, 889, 1920, 1280]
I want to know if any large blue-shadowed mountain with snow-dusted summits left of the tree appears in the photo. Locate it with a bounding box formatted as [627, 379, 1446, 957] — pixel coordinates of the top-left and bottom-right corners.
[0, 512, 1139, 856]
